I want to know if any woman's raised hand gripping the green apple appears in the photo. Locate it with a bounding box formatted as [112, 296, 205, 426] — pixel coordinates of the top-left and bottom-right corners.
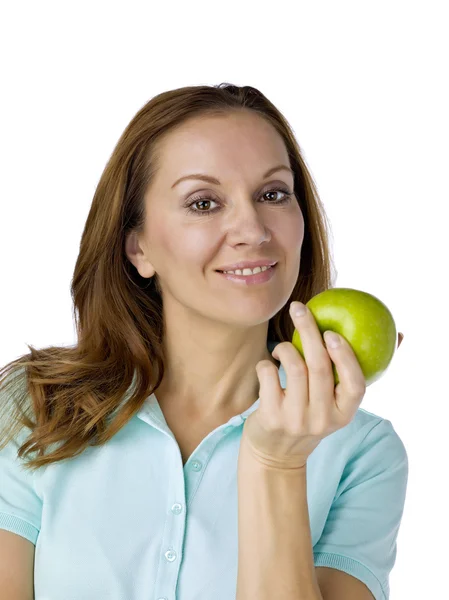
[242, 302, 404, 469]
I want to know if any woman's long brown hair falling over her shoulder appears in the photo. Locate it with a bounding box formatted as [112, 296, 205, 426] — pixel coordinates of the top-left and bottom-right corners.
[0, 83, 333, 471]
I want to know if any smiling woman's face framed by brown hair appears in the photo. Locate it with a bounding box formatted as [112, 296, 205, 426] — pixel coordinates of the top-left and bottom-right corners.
[132, 113, 304, 328]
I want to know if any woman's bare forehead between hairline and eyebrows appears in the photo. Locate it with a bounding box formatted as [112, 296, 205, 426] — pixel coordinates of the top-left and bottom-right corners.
[152, 113, 289, 183]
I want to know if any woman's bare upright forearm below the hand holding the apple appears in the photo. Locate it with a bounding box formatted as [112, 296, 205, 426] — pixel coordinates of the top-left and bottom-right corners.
[237, 437, 323, 600]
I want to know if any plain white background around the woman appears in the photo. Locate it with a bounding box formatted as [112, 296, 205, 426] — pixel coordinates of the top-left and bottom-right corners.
[0, 0, 449, 600]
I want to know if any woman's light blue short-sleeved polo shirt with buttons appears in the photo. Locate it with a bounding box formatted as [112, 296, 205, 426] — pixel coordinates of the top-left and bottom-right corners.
[0, 342, 408, 600]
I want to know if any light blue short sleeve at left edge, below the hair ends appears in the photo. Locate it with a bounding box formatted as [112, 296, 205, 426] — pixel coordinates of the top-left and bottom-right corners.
[0, 414, 42, 545]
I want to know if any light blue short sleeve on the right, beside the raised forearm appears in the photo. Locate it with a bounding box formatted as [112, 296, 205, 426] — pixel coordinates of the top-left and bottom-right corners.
[313, 419, 408, 600]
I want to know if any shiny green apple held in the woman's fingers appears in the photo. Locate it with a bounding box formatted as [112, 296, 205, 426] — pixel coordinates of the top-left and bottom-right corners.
[292, 288, 398, 386]
